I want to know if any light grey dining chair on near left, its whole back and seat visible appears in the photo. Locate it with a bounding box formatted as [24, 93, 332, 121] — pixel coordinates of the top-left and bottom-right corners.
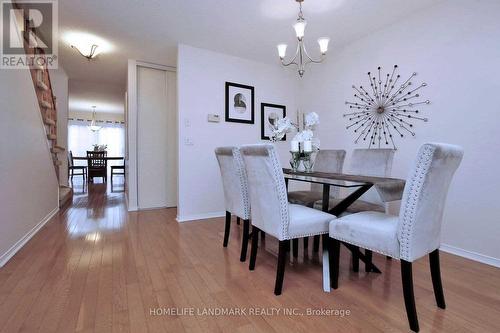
[240, 144, 335, 295]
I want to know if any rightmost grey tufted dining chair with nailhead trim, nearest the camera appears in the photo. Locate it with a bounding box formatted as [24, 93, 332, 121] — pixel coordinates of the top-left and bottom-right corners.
[329, 143, 463, 332]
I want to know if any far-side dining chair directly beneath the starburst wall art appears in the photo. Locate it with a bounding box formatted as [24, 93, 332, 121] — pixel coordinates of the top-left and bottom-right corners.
[314, 149, 396, 272]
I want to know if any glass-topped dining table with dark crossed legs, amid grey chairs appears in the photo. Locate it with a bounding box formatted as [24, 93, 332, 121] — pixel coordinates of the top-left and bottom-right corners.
[283, 168, 405, 292]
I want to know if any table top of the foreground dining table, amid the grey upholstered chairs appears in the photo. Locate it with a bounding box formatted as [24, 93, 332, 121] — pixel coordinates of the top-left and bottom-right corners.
[283, 168, 405, 202]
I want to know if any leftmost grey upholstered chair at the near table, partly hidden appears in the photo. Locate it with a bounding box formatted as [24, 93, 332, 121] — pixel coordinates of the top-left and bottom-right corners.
[215, 147, 250, 261]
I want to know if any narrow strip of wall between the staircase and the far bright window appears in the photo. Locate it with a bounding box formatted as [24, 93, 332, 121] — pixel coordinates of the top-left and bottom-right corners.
[49, 66, 68, 185]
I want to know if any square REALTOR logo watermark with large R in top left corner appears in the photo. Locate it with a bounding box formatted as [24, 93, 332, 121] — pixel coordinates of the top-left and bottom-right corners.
[0, 0, 58, 69]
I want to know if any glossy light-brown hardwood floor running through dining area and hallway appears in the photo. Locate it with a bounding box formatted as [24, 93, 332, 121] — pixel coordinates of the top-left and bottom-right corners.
[0, 181, 500, 333]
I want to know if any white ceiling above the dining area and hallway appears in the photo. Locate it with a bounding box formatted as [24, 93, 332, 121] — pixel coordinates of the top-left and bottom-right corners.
[59, 0, 438, 87]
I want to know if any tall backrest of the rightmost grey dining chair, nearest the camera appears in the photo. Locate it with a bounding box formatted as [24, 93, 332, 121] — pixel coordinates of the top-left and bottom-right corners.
[398, 143, 463, 262]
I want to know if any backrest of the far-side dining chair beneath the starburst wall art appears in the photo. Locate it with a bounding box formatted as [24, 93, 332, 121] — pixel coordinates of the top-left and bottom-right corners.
[348, 149, 396, 205]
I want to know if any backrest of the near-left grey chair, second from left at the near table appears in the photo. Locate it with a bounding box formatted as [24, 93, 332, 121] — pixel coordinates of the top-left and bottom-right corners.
[240, 144, 290, 240]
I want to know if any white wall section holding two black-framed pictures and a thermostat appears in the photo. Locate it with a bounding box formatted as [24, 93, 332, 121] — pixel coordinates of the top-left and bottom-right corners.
[177, 45, 297, 221]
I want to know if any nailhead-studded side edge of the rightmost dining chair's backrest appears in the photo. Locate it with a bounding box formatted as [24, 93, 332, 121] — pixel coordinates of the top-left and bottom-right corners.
[399, 145, 436, 261]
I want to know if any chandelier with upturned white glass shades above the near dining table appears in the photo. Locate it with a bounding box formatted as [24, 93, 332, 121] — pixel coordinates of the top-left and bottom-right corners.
[277, 0, 330, 77]
